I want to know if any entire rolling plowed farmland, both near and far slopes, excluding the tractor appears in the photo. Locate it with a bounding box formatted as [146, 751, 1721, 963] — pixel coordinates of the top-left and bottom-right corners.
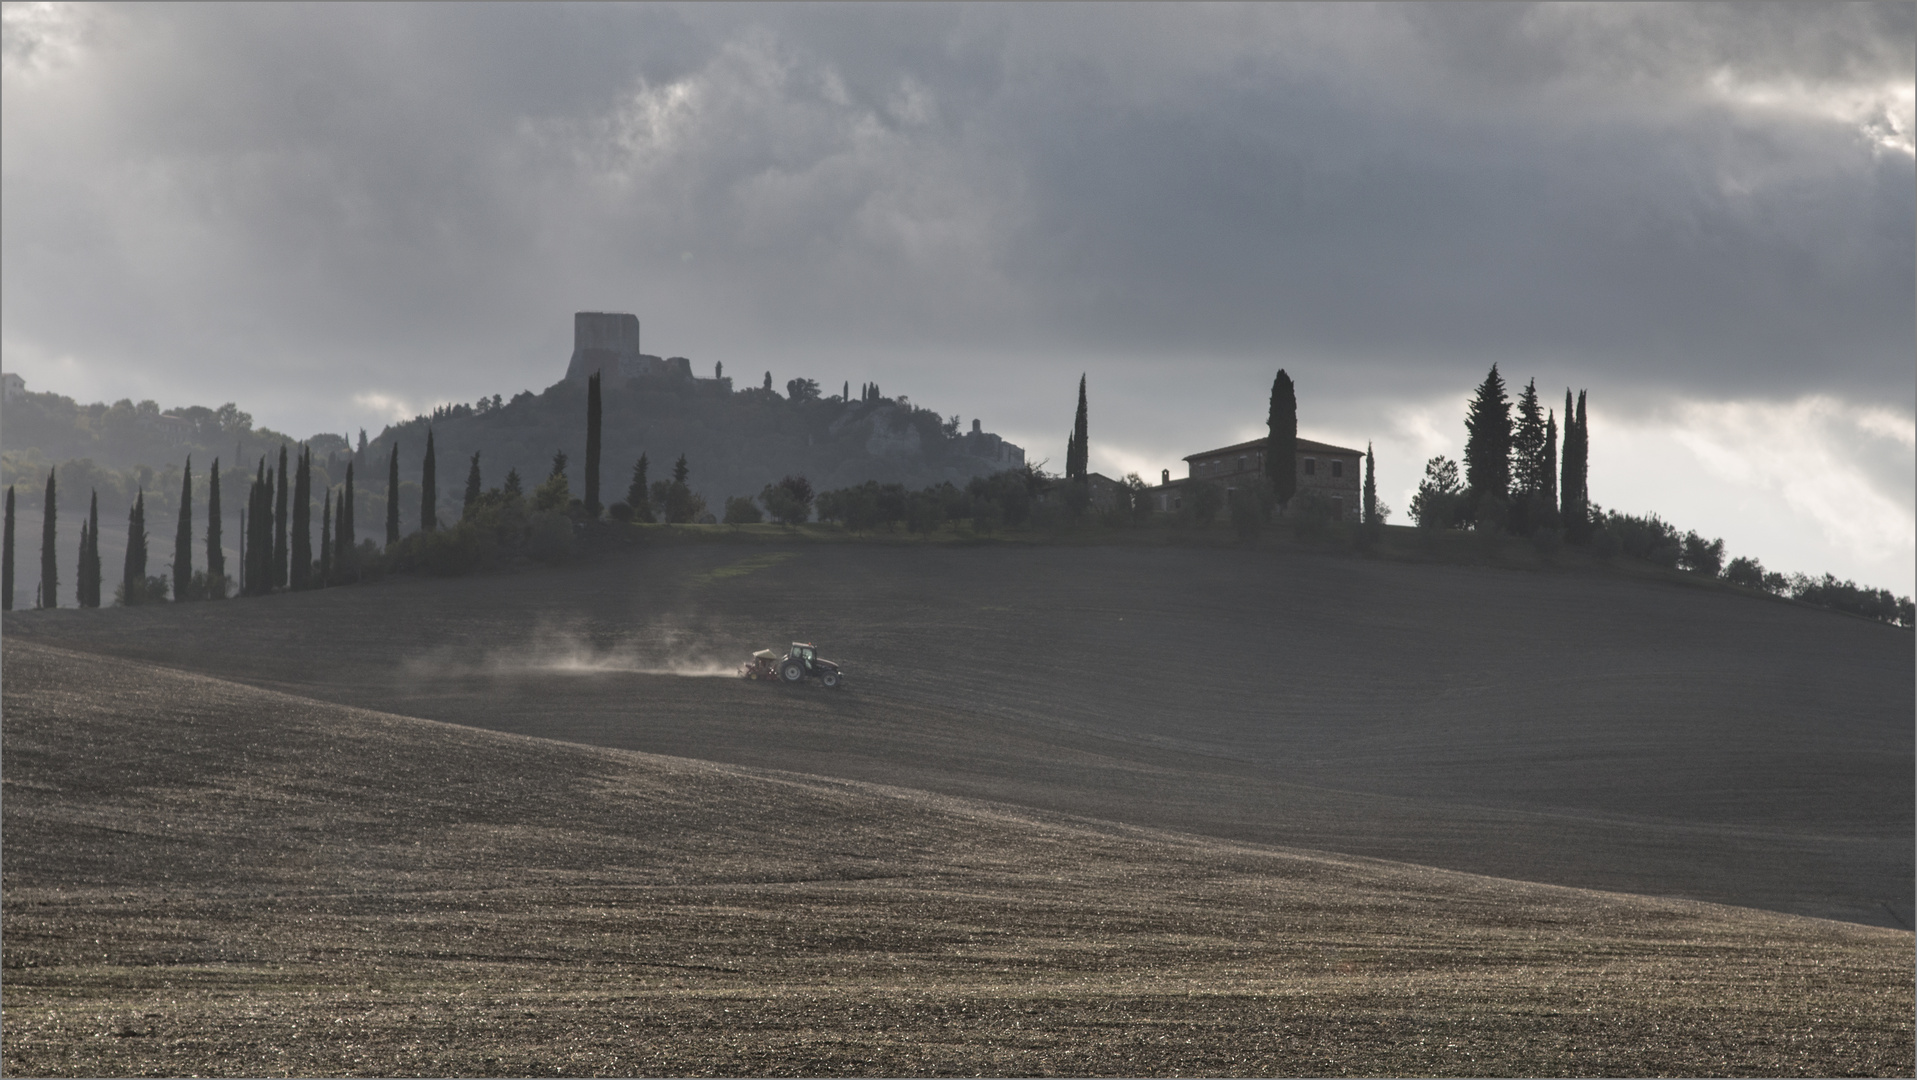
[4, 543, 1913, 1074]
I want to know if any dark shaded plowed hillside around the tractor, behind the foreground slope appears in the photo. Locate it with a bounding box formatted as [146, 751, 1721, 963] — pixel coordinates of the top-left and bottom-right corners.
[8, 543, 1917, 928]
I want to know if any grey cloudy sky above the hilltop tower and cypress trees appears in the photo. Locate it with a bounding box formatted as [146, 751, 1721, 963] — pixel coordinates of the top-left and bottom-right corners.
[0, 4, 1917, 593]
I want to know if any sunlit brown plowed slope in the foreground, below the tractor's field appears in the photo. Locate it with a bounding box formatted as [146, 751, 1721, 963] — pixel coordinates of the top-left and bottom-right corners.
[4, 639, 1913, 1074]
